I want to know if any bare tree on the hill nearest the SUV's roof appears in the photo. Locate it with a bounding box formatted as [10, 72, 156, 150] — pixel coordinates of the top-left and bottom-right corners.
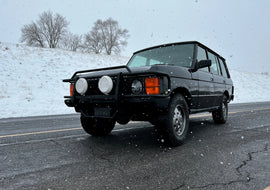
[85, 18, 129, 55]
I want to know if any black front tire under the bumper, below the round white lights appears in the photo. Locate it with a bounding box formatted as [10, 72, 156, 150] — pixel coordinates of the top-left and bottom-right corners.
[81, 116, 115, 137]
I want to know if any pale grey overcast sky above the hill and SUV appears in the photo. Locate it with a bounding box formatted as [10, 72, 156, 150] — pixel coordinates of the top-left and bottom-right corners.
[0, 0, 270, 73]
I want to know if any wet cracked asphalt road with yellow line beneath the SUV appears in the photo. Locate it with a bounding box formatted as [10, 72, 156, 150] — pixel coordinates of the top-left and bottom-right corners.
[0, 102, 270, 190]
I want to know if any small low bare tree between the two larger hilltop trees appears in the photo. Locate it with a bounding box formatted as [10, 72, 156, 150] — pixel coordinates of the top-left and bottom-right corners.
[61, 32, 82, 51]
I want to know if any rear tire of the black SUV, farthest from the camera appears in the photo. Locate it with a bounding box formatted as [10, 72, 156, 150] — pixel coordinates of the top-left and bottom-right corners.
[212, 95, 228, 124]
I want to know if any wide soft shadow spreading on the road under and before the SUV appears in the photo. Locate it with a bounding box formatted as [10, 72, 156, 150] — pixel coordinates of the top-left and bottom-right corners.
[63, 119, 232, 168]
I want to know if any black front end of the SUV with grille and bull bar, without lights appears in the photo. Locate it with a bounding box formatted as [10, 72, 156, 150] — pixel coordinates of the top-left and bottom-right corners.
[64, 67, 170, 118]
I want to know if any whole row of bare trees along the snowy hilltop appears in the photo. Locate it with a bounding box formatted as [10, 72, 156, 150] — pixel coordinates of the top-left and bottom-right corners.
[20, 11, 129, 55]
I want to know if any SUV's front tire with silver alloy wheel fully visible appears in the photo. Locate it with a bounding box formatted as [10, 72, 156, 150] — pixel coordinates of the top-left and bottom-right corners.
[161, 94, 189, 146]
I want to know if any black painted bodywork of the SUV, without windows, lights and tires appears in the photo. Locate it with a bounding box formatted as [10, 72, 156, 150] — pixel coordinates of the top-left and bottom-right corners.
[64, 42, 234, 120]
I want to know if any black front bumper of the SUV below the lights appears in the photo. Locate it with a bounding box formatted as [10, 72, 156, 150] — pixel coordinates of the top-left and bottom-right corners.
[65, 95, 170, 118]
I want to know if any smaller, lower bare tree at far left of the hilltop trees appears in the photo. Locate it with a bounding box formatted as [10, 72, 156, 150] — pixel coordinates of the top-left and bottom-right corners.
[21, 22, 44, 47]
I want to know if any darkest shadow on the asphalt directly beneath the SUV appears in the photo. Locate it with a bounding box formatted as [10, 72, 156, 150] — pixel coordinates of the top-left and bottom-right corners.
[76, 116, 226, 149]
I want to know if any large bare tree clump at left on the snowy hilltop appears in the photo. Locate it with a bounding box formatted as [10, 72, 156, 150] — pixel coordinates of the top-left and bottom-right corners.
[21, 11, 68, 48]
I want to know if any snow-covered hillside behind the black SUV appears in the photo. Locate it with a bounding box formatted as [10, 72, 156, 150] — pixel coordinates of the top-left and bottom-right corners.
[0, 42, 270, 118]
